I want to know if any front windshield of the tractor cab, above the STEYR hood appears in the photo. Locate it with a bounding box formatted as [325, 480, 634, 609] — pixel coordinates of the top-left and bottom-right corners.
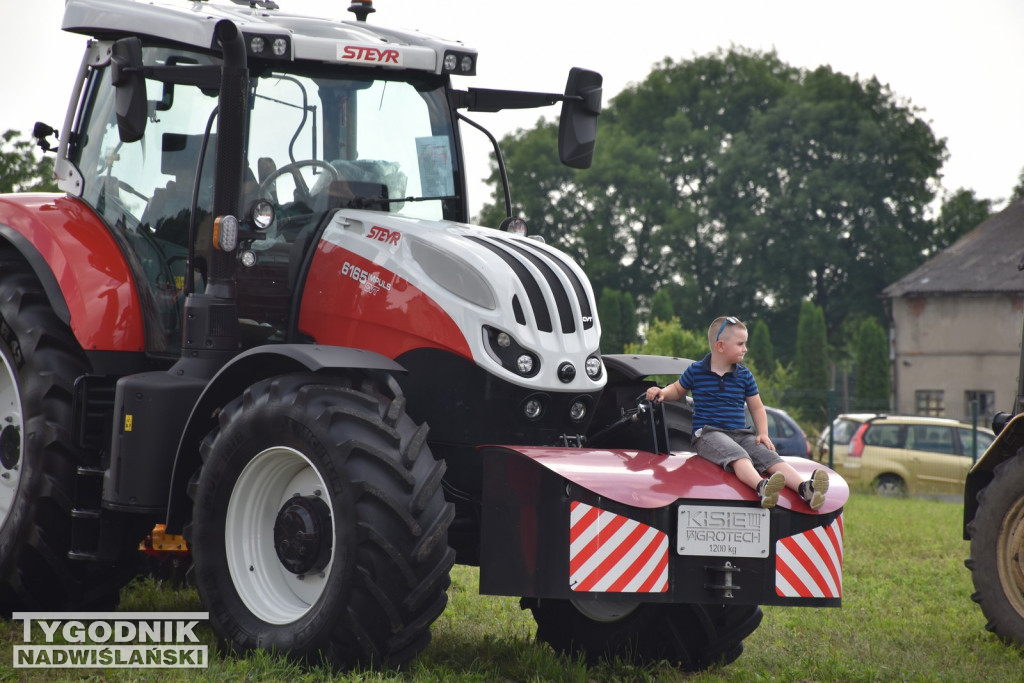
[248, 64, 458, 219]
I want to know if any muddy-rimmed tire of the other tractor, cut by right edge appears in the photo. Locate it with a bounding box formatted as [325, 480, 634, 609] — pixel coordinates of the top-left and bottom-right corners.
[967, 450, 1024, 644]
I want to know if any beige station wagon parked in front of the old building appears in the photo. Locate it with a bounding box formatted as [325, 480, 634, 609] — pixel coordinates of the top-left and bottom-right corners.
[834, 415, 995, 496]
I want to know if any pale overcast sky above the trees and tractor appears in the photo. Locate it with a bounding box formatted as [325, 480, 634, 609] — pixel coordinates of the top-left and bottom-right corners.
[0, 0, 1024, 212]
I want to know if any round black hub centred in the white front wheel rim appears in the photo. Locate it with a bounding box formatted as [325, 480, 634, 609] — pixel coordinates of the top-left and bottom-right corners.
[273, 496, 333, 574]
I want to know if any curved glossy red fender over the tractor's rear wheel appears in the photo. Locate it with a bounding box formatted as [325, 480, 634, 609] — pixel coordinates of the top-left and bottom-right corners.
[0, 194, 145, 351]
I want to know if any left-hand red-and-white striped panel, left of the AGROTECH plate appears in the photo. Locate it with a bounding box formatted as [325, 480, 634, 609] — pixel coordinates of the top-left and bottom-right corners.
[569, 501, 669, 593]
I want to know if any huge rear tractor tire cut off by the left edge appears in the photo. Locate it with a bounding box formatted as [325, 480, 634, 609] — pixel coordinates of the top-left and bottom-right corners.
[0, 254, 131, 615]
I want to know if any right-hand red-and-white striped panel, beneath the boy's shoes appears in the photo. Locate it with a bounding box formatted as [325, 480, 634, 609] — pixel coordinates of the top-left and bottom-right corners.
[775, 515, 843, 598]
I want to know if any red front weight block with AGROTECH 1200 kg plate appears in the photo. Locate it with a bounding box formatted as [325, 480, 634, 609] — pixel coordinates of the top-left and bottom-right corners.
[480, 446, 849, 607]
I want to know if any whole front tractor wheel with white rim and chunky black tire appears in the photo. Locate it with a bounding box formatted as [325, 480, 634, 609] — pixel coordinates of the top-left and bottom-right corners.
[185, 375, 455, 669]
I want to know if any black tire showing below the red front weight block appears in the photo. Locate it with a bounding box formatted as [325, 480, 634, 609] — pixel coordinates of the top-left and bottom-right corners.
[522, 598, 762, 671]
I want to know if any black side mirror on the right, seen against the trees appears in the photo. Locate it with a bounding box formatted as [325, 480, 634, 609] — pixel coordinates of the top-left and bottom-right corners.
[558, 67, 603, 168]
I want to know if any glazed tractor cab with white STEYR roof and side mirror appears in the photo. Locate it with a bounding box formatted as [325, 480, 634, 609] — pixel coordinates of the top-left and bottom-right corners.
[55, 1, 601, 357]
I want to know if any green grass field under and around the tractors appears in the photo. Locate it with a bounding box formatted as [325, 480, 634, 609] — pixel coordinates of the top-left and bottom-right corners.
[0, 495, 1024, 683]
